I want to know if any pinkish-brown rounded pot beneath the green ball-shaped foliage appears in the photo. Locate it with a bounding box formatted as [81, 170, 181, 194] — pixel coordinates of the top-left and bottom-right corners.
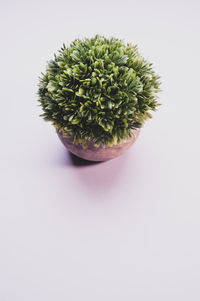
[58, 129, 140, 161]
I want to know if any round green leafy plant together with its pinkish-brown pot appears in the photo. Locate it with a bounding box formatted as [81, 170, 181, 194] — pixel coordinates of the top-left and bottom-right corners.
[38, 35, 160, 161]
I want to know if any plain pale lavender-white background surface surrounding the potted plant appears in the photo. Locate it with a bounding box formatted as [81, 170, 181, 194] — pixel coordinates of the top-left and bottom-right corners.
[0, 0, 200, 301]
